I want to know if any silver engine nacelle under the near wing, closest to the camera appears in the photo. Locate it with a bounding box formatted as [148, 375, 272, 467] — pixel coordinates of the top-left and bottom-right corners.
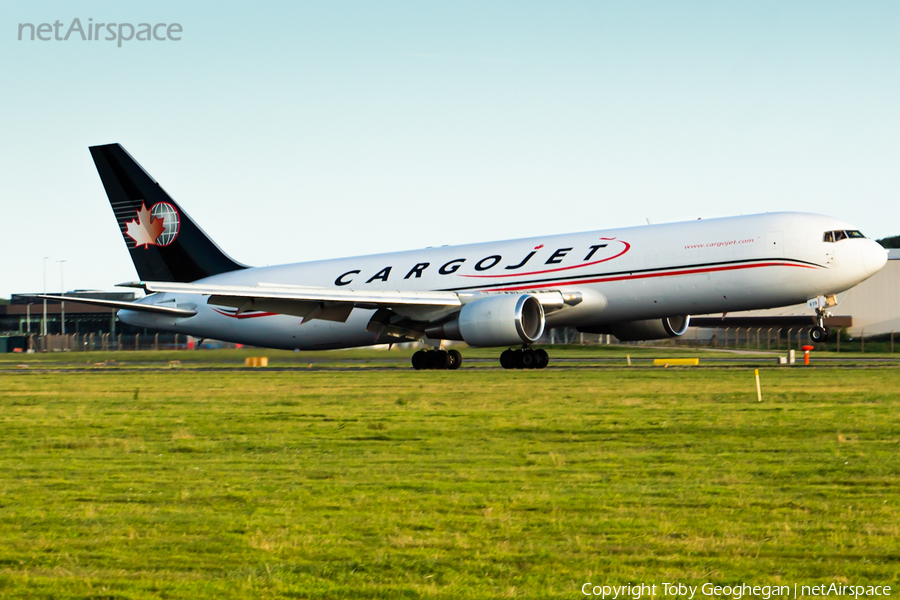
[425, 294, 544, 347]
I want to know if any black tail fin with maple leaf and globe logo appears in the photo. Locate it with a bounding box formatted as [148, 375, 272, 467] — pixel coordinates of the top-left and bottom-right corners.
[90, 144, 246, 282]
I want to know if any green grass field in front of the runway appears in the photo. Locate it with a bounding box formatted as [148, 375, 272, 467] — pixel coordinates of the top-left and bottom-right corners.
[0, 351, 900, 598]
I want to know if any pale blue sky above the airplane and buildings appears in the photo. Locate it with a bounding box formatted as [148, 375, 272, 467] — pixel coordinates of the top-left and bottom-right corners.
[0, 0, 900, 297]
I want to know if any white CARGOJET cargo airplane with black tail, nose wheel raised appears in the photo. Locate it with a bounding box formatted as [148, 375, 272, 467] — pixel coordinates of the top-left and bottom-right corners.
[42, 144, 887, 369]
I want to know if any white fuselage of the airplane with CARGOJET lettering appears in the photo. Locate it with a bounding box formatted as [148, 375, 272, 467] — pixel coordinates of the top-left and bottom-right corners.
[120, 213, 886, 350]
